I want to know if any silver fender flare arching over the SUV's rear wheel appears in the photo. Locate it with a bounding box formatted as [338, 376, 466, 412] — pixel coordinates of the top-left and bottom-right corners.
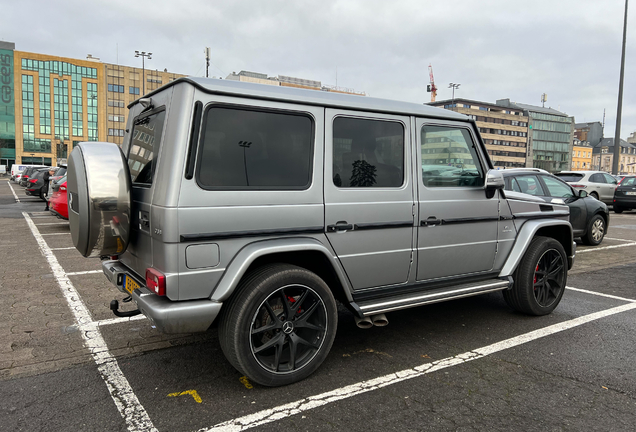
[210, 237, 353, 302]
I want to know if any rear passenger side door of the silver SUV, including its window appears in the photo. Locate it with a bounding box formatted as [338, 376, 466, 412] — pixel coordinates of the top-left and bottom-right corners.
[324, 109, 414, 290]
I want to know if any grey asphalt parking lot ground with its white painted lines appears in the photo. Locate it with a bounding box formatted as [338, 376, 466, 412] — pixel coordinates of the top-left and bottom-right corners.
[0, 180, 636, 431]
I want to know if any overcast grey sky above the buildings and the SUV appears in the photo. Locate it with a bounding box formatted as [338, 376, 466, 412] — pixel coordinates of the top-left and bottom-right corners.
[0, 0, 636, 139]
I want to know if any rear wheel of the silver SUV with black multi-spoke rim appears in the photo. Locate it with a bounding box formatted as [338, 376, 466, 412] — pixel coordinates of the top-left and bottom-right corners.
[219, 264, 338, 387]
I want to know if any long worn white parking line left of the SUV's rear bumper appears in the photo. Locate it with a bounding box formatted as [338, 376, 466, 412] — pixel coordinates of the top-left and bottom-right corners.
[22, 212, 157, 432]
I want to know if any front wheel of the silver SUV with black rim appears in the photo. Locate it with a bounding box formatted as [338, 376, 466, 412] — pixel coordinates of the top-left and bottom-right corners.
[503, 237, 567, 315]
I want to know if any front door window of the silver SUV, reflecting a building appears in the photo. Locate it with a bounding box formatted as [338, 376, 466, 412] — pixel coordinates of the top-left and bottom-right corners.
[421, 126, 484, 187]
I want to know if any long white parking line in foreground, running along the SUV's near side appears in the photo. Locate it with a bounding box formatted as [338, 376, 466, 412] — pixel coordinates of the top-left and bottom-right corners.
[199, 303, 636, 432]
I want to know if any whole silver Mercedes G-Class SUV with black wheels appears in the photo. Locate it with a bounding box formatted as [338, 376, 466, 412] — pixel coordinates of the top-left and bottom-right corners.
[68, 78, 576, 386]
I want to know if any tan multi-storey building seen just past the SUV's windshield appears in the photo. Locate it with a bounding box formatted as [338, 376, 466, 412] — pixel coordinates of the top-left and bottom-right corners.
[429, 98, 528, 169]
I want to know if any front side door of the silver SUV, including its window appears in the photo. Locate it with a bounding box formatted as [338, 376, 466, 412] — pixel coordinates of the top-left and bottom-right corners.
[416, 119, 499, 281]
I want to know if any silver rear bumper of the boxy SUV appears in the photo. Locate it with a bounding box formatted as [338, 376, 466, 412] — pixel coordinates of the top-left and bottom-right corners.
[102, 260, 223, 333]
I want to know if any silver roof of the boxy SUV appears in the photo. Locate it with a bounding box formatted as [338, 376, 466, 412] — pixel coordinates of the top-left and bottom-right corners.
[128, 77, 469, 121]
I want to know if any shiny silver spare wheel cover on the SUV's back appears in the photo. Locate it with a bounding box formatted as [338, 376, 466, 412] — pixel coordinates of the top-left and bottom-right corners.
[67, 142, 131, 257]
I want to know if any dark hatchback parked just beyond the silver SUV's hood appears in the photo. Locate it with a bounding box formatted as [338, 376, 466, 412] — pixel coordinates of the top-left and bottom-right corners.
[503, 168, 609, 246]
